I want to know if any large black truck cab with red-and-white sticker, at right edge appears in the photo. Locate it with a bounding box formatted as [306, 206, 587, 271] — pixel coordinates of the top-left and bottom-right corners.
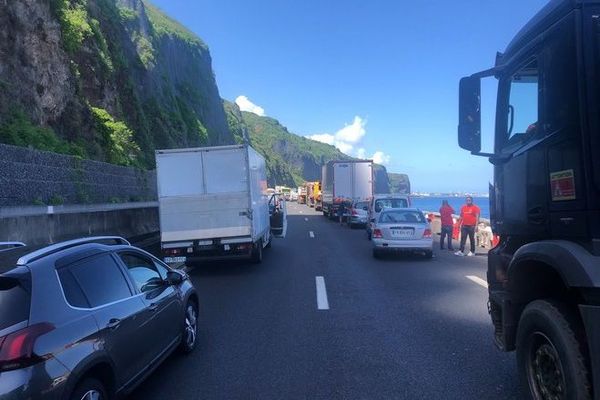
[458, 0, 600, 399]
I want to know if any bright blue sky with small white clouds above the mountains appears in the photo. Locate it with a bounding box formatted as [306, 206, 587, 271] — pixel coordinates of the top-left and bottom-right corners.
[152, 0, 547, 192]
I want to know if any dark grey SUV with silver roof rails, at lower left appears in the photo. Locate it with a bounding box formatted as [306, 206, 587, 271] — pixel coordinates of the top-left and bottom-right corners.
[0, 237, 198, 400]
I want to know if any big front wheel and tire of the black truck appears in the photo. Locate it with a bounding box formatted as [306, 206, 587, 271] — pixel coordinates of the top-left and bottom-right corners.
[517, 300, 592, 400]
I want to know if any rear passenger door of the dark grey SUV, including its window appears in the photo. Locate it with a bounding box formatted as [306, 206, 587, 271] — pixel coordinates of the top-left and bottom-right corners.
[57, 253, 149, 387]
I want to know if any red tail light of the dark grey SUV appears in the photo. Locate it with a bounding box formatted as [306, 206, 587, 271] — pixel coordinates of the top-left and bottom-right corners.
[0, 322, 54, 372]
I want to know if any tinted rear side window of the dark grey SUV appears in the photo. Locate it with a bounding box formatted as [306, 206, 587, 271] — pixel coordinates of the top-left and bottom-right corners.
[58, 254, 131, 308]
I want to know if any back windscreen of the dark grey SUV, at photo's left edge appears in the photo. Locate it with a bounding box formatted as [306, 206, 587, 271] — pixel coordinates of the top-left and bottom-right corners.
[0, 277, 31, 330]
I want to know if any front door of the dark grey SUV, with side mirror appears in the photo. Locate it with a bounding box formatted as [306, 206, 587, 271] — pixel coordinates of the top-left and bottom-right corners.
[117, 251, 183, 362]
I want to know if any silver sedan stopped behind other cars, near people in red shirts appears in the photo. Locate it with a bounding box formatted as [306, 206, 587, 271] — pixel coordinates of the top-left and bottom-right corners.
[372, 208, 433, 258]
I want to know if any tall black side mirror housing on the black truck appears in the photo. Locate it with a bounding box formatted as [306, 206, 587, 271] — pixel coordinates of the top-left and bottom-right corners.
[458, 76, 481, 153]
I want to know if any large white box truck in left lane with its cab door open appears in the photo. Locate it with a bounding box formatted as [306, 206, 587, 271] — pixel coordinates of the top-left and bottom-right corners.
[156, 145, 286, 265]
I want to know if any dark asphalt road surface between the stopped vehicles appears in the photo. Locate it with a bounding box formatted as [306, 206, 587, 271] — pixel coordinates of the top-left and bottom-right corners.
[131, 204, 520, 400]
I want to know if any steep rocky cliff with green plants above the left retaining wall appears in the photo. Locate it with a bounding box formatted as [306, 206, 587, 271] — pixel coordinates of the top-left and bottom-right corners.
[0, 0, 234, 167]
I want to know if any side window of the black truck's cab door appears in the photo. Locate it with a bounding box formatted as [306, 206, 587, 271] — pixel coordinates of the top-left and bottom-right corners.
[506, 60, 540, 149]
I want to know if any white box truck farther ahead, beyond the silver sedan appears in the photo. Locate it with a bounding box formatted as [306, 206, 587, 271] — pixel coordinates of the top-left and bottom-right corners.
[321, 160, 374, 217]
